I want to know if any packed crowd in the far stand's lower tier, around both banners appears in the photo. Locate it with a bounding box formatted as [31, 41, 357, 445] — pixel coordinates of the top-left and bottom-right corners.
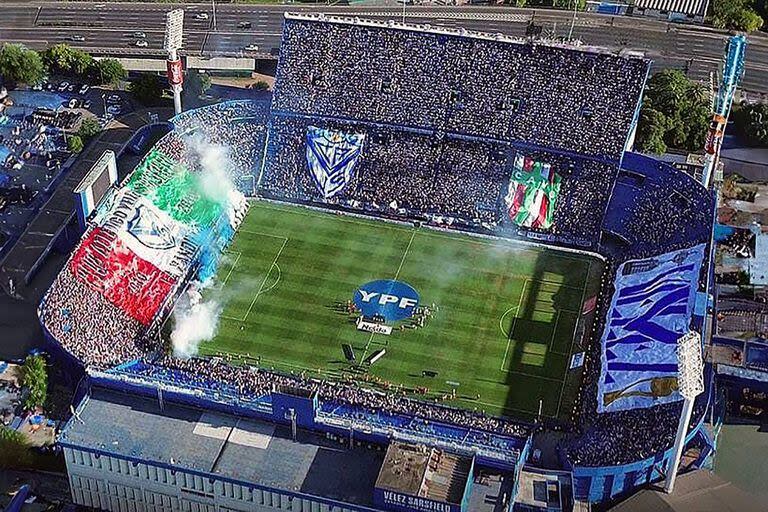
[259, 116, 617, 242]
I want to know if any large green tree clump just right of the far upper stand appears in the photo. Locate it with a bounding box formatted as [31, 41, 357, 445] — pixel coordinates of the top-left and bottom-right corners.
[637, 69, 711, 153]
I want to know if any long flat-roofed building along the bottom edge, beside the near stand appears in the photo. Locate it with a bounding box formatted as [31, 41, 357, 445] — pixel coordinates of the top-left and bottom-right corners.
[59, 387, 507, 512]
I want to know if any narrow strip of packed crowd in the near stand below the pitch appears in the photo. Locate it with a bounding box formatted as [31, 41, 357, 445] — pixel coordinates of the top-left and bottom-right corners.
[143, 356, 528, 437]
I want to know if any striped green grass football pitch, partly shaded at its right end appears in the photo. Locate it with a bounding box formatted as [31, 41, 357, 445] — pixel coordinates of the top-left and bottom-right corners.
[200, 201, 600, 418]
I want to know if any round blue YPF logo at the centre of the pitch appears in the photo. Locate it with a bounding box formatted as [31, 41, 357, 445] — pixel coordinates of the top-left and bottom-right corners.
[354, 279, 419, 322]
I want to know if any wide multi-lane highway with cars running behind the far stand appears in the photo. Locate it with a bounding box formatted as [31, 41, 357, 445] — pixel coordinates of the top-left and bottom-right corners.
[0, 2, 768, 93]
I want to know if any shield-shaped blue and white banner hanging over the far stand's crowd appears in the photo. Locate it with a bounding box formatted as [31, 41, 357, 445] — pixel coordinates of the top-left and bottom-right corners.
[307, 126, 365, 199]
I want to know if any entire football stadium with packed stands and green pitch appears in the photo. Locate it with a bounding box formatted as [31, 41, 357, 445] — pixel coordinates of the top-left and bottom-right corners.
[39, 15, 715, 511]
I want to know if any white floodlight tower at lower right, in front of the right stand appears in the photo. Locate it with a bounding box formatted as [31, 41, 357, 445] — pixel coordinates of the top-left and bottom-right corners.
[664, 331, 704, 493]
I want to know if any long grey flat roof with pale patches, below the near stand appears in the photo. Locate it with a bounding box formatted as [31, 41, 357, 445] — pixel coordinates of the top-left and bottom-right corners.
[60, 388, 384, 506]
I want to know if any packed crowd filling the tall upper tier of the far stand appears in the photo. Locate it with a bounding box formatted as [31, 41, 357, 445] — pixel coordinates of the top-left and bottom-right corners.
[273, 18, 649, 157]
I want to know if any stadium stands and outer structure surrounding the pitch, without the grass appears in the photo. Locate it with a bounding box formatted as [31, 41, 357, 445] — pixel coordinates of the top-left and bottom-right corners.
[45, 15, 714, 512]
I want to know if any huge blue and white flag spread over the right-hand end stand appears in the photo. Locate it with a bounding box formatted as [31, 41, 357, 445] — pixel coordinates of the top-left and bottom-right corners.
[597, 245, 704, 412]
